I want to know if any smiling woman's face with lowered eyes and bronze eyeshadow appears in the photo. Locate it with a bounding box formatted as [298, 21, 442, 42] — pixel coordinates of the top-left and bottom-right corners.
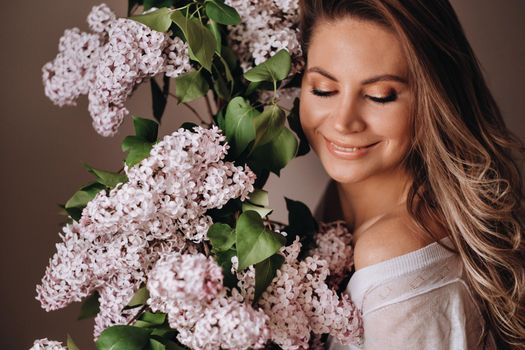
[300, 18, 413, 183]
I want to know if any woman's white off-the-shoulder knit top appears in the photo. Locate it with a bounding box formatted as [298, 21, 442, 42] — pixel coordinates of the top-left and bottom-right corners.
[328, 237, 496, 350]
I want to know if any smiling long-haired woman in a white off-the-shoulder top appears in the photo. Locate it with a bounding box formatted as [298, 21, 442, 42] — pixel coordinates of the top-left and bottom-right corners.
[300, 0, 525, 349]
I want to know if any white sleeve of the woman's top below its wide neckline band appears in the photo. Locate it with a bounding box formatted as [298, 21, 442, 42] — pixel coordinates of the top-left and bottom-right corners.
[363, 281, 483, 350]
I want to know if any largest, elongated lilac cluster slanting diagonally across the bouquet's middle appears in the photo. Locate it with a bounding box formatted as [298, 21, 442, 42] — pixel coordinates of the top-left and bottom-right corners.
[33, 126, 255, 335]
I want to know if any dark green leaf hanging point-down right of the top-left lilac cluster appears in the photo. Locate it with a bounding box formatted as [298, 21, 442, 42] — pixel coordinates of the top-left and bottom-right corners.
[171, 11, 216, 72]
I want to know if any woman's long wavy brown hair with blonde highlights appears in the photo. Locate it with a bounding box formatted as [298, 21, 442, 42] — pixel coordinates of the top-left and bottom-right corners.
[300, 0, 525, 349]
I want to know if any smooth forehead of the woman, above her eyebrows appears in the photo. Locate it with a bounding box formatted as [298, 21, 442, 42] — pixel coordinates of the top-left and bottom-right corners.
[308, 17, 407, 78]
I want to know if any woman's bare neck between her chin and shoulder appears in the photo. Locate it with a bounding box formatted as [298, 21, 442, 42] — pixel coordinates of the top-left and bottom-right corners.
[337, 165, 412, 233]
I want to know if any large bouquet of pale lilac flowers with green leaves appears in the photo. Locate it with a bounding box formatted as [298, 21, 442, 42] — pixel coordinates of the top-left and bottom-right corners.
[32, 0, 363, 350]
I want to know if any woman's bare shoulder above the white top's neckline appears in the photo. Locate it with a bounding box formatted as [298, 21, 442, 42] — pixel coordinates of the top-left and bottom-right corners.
[354, 216, 444, 271]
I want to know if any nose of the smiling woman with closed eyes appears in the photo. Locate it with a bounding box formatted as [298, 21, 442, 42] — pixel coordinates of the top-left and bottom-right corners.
[333, 94, 366, 134]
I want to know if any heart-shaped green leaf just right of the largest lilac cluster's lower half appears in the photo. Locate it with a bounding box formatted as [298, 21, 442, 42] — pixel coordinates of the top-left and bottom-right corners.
[235, 211, 286, 270]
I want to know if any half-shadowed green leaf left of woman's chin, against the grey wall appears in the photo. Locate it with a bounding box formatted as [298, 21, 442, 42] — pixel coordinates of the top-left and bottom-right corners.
[252, 128, 298, 175]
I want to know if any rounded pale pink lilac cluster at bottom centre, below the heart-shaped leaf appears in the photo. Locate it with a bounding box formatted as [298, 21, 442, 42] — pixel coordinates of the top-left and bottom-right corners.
[147, 253, 269, 350]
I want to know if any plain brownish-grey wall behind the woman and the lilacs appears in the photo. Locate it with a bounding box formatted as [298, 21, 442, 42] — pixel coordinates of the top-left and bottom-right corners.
[0, 0, 525, 350]
